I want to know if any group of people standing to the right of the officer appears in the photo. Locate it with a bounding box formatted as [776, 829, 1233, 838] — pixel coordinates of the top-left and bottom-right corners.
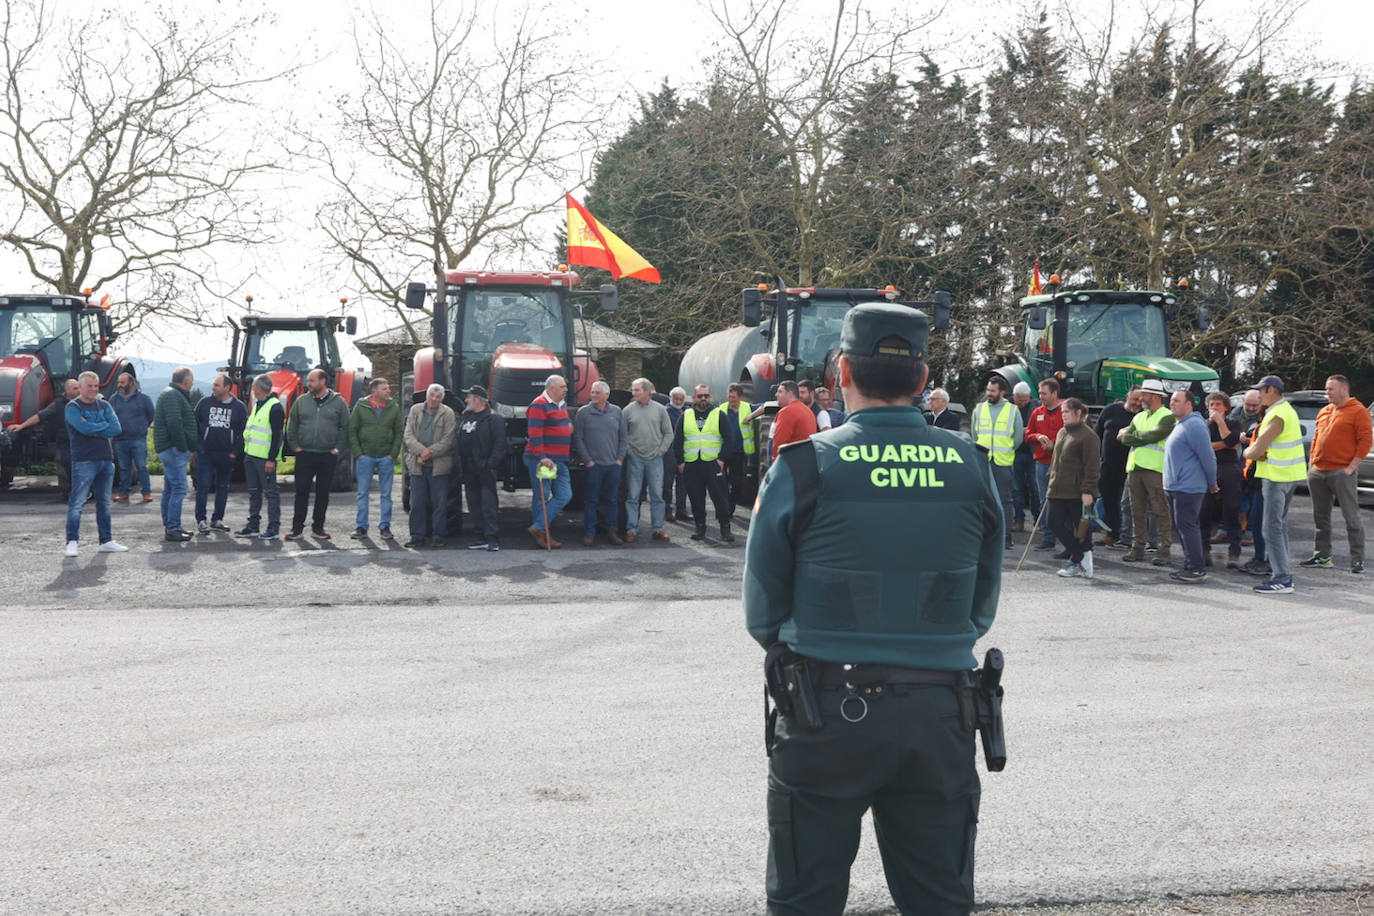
[972, 375, 1374, 595]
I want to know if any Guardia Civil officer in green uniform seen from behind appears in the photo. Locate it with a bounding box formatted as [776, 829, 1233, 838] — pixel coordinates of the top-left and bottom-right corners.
[743, 304, 1004, 916]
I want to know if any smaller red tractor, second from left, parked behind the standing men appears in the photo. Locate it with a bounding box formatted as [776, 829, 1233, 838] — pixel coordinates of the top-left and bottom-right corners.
[223, 297, 368, 490]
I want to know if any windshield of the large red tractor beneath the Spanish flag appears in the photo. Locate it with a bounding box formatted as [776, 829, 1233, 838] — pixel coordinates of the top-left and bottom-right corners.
[451, 287, 573, 387]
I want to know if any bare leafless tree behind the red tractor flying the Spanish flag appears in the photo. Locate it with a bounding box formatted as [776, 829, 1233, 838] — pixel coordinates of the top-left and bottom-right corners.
[317, 0, 600, 343]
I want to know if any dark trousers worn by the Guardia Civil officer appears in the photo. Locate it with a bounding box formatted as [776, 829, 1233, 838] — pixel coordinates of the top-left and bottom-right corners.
[767, 684, 981, 916]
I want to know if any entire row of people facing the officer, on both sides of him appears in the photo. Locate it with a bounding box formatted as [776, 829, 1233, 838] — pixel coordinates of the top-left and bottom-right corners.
[37, 367, 1374, 593]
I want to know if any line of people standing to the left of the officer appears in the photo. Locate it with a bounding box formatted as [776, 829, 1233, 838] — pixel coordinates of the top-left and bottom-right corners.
[48, 367, 844, 556]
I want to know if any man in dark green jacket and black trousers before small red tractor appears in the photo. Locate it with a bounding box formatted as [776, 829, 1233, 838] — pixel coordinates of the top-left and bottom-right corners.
[286, 369, 349, 541]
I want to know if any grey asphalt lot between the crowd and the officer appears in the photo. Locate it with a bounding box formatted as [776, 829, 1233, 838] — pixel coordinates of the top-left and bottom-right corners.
[0, 482, 1374, 915]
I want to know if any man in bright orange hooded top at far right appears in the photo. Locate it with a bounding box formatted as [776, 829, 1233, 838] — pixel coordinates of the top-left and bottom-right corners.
[1300, 375, 1374, 573]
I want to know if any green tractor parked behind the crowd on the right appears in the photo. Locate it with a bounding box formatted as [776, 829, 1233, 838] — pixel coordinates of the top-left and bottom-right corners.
[987, 290, 1220, 413]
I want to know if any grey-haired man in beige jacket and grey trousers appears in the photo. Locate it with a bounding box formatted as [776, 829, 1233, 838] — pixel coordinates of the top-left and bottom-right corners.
[403, 385, 456, 548]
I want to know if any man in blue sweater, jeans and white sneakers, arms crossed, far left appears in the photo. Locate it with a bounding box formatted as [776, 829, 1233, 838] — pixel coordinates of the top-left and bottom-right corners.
[65, 372, 129, 556]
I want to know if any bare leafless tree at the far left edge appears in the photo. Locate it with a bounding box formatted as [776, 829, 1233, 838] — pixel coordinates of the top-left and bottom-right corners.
[0, 0, 281, 328]
